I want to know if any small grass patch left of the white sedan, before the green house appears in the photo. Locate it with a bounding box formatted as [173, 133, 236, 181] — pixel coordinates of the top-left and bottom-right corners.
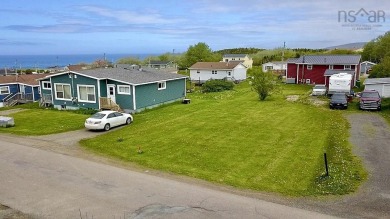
[0, 108, 88, 135]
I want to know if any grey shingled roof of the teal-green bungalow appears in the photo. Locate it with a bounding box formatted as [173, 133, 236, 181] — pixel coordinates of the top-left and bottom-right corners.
[62, 68, 187, 85]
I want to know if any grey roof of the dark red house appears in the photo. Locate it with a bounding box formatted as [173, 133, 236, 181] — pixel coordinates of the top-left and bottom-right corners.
[288, 55, 361, 65]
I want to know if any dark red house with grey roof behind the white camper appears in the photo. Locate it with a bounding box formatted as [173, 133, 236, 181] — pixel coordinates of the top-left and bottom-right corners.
[286, 55, 361, 85]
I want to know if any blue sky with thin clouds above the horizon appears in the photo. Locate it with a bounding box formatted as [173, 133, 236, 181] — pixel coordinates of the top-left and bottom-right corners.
[0, 0, 390, 55]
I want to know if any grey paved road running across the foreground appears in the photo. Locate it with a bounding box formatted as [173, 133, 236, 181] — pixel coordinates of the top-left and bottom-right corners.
[0, 139, 336, 218]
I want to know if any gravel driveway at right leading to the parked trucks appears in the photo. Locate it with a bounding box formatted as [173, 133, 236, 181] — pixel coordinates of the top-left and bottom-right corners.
[291, 112, 390, 218]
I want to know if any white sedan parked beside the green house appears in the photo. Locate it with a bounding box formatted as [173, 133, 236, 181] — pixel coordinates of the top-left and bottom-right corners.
[84, 110, 133, 131]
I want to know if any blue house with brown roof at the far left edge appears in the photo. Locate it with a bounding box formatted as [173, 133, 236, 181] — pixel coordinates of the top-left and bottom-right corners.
[0, 74, 45, 107]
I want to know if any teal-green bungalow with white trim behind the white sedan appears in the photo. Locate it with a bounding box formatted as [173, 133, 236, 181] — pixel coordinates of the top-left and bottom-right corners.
[40, 68, 187, 113]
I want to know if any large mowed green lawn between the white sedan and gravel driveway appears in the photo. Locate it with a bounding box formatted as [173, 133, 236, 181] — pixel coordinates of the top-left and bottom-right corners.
[81, 83, 365, 196]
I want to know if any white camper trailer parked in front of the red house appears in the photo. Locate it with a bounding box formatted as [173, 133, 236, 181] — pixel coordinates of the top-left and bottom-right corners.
[328, 72, 352, 95]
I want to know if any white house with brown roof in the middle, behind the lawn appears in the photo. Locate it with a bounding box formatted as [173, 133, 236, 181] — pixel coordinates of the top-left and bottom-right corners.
[189, 61, 247, 83]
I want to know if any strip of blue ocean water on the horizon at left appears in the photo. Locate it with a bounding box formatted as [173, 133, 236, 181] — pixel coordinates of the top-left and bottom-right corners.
[0, 54, 155, 69]
